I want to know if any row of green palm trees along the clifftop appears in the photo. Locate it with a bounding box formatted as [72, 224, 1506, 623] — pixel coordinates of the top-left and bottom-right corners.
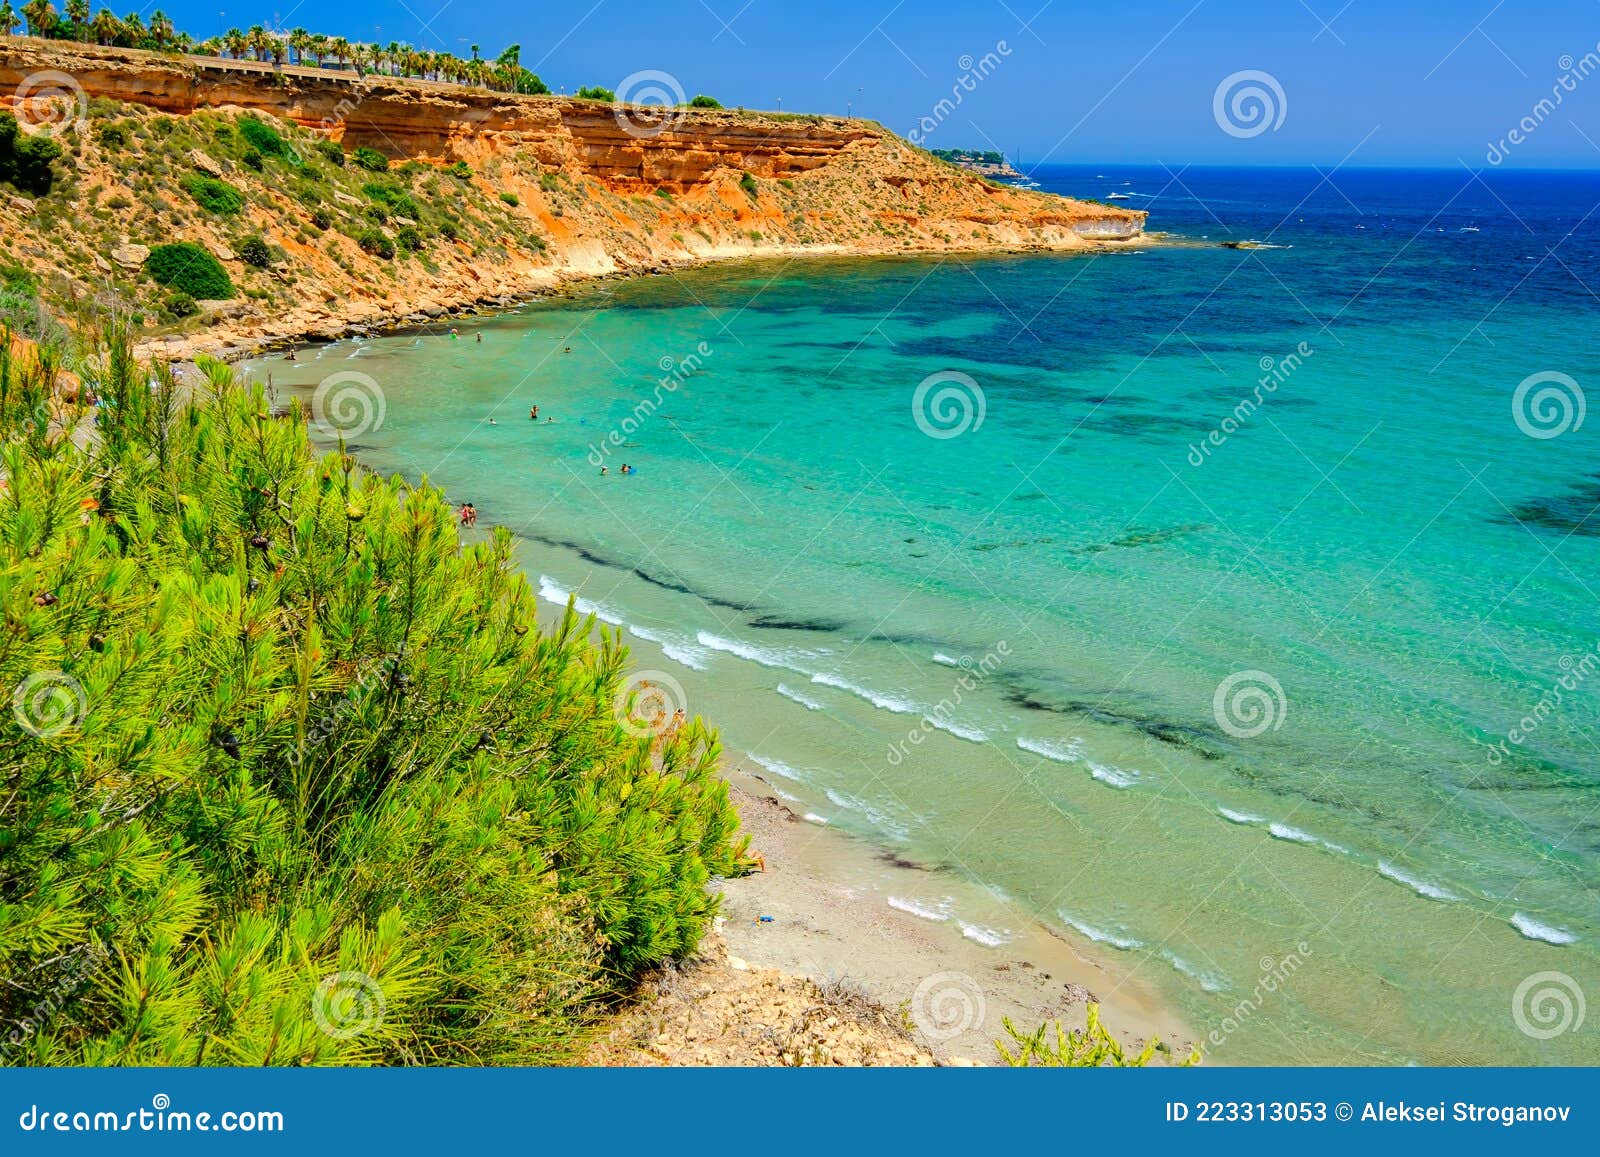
[0, 0, 550, 96]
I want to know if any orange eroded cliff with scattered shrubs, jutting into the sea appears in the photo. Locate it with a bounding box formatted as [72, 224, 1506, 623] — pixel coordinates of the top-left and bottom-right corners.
[0, 38, 1144, 355]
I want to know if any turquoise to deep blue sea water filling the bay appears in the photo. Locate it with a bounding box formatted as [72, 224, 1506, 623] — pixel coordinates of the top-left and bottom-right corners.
[246, 170, 1600, 1064]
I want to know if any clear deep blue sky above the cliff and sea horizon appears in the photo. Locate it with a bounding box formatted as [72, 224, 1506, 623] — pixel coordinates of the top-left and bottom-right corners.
[152, 0, 1600, 168]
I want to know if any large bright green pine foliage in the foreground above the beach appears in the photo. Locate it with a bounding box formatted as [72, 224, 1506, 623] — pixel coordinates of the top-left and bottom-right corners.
[0, 307, 742, 1064]
